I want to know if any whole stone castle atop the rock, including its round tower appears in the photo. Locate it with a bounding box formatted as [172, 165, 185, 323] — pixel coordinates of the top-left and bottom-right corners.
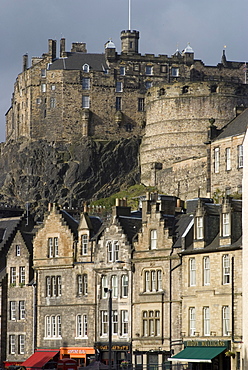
[6, 30, 248, 145]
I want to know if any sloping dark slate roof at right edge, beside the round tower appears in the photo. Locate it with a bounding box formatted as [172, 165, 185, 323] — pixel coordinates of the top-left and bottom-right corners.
[214, 108, 248, 141]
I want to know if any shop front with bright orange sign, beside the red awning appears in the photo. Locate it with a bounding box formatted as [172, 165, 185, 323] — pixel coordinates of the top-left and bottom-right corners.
[60, 347, 95, 366]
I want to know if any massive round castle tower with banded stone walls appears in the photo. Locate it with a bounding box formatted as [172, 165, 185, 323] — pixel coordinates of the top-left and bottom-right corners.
[140, 81, 248, 191]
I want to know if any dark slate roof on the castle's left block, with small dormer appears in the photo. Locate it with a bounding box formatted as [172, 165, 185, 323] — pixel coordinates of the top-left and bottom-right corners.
[49, 53, 108, 71]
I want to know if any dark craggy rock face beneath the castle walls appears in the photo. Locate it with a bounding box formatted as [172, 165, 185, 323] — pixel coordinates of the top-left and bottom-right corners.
[0, 137, 140, 217]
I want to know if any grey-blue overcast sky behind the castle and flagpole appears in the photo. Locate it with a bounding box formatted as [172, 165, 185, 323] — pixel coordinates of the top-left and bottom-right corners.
[0, 0, 248, 141]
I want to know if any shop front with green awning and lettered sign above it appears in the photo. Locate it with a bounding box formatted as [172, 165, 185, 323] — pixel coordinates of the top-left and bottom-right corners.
[168, 340, 231, 370]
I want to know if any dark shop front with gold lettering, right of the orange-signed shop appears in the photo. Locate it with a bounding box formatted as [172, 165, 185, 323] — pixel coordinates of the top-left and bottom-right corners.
[95, 342, 131, 369]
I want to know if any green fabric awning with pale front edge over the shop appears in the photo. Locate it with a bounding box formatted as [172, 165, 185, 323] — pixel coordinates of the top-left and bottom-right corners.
[168, 347, 226, 363]
